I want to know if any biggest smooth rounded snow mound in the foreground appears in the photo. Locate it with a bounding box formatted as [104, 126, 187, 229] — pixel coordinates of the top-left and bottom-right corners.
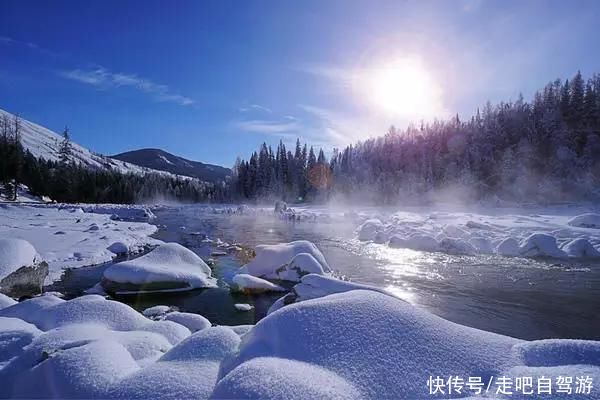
[223, 291, 519, 398]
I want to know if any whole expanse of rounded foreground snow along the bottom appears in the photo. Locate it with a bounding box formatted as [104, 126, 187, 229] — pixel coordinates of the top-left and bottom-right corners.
[0, 282, 600, 399]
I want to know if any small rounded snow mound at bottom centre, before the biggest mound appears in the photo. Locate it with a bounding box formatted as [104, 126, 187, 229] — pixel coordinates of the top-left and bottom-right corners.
[211, 357, 362, 400]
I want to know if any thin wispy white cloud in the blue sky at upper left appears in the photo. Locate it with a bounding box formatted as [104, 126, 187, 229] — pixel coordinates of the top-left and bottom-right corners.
[59, 67, 195, 106]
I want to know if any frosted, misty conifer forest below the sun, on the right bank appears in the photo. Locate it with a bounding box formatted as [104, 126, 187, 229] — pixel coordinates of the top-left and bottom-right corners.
[232, 72, 600, 204]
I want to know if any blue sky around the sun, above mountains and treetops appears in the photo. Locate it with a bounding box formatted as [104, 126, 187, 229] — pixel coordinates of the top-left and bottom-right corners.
[0, 0, 600, 166]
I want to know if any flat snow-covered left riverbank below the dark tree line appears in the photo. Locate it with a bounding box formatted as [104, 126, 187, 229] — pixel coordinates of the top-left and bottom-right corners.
[0, 204, 160, 283]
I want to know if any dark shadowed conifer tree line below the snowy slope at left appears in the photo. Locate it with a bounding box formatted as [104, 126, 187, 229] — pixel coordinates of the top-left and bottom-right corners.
[0, 115, 227, 204]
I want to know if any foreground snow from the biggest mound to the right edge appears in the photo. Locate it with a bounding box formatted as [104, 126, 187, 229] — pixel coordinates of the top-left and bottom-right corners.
[220, 290, 600, 399]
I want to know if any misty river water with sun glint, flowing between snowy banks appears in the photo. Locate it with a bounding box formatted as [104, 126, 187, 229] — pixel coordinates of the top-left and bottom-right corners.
[52, 206, 600, 340]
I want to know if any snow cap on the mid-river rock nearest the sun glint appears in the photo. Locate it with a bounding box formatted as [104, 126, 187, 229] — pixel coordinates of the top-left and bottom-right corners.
[240, 240, 331, 279]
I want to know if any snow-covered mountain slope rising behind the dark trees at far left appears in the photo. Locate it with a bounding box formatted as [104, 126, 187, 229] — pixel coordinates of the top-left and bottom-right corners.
[0, 109, 199, 177]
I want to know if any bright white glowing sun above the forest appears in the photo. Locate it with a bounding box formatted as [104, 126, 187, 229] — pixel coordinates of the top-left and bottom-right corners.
[360, 58, 441, 118]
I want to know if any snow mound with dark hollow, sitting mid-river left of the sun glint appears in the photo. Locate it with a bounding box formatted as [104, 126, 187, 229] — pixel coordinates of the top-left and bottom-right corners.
[240, 240, 331, 280]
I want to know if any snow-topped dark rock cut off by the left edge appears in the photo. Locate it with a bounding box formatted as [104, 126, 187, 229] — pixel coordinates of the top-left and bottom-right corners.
[0, 239, 48, 297]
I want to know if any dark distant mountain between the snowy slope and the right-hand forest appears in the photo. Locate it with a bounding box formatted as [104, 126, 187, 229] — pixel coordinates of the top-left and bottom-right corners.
[111, 149, 231, 182]
